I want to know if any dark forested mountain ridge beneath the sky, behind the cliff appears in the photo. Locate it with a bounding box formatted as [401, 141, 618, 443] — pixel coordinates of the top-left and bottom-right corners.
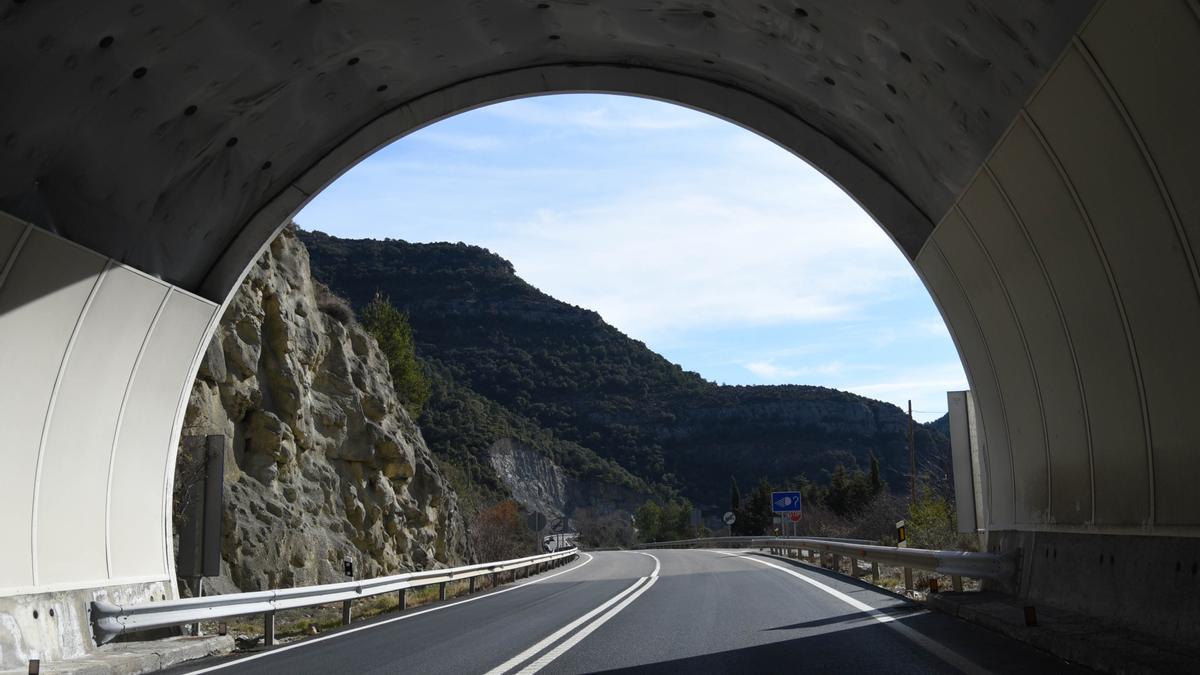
[298, 229, 948, 510]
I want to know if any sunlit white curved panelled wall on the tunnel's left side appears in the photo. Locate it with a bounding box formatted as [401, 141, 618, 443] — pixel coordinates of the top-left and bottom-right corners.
[0, 217, 216, 597]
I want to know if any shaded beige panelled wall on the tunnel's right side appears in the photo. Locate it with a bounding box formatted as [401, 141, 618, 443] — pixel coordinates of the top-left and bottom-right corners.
[916, 2, 1200, 536]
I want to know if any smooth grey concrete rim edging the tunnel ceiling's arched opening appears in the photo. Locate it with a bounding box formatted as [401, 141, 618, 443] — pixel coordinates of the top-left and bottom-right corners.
[200, 64, 934, 298]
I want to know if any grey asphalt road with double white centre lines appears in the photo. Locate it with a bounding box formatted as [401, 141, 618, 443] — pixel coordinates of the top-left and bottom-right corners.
[172, 550, 1089, 675]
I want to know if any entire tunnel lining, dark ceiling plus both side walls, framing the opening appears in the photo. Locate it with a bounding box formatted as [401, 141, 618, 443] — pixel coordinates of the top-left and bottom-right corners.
[0, 0, 1200, 664]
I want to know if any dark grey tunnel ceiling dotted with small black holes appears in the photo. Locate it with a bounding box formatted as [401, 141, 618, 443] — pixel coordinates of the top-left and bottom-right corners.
[0, 0, 1091, 288]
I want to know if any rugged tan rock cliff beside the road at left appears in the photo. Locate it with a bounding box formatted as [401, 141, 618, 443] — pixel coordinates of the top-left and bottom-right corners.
[176, 231, 470, 591]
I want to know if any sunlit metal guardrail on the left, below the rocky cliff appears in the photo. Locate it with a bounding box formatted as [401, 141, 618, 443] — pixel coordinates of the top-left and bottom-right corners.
[90, 548, 578, 645]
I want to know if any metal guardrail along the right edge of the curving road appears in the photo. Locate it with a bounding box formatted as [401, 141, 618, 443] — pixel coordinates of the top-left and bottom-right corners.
[636, 537, 1016, 590]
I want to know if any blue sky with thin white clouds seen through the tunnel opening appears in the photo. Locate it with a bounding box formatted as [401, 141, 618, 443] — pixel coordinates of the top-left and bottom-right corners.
[296, 94, 966, 420]
